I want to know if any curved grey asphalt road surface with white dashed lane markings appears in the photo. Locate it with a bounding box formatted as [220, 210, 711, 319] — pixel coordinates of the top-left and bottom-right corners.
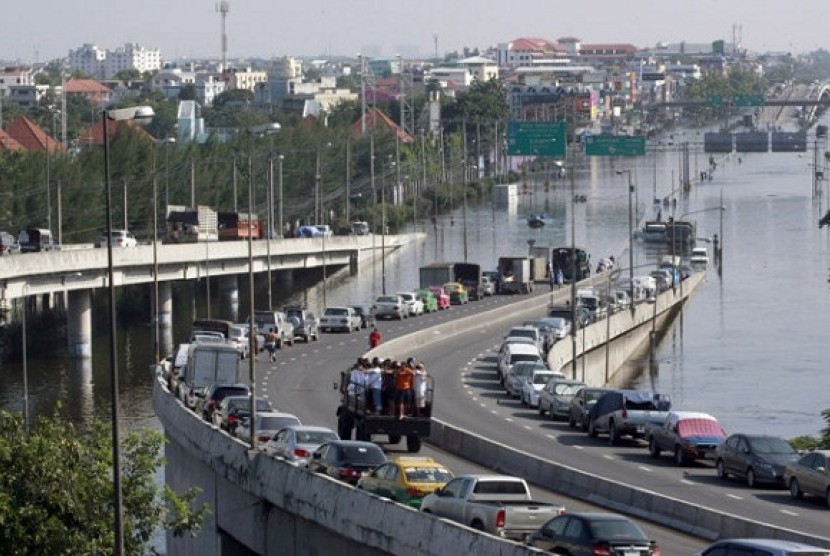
[257, 286, 827, 554]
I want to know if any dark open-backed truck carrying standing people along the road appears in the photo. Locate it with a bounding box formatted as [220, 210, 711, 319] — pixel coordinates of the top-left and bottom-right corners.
[334, 370, 434, 453]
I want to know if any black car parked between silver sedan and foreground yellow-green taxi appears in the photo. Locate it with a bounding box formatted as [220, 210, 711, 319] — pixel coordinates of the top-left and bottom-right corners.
[306, 440, 386, 485]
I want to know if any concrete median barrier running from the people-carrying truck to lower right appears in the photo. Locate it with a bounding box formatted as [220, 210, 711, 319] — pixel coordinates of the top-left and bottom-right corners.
[429, 420, 830, 548]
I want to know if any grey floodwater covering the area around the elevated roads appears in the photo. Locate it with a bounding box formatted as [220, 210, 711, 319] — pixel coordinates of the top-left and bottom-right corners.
[0, 121, 830, 444]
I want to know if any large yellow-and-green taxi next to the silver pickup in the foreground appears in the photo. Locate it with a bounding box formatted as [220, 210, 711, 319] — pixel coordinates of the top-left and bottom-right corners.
[357, 456, 453, 508]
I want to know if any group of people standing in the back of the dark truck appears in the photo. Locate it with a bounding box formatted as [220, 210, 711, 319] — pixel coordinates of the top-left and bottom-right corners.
[348, 357, 429, 419]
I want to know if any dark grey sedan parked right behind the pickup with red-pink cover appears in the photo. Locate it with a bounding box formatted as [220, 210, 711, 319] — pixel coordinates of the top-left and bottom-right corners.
[715, 433, 798, 488]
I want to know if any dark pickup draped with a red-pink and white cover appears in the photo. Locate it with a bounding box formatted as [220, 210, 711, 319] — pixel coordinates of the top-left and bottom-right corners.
[646, 411, 726, 465]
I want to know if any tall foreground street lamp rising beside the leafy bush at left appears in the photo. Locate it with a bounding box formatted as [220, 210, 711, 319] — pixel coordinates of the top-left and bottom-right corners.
[101, 106, 154, 556]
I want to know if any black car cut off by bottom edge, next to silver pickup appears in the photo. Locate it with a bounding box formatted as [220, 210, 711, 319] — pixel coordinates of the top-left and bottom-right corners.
[527, 513, 660, 556]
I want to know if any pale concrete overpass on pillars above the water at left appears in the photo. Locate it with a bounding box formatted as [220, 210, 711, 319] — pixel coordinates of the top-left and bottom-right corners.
[0, 235, 411, 357]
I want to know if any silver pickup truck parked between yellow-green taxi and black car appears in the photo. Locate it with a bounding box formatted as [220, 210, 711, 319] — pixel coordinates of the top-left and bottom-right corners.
[421, 475, 565, 541]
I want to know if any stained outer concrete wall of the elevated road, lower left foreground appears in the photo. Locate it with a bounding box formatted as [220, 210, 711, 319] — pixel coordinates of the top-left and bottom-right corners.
[153, 382, 539, 556]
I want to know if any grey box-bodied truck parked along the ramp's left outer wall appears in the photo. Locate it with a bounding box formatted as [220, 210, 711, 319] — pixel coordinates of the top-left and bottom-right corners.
[176, 342, 240, 410]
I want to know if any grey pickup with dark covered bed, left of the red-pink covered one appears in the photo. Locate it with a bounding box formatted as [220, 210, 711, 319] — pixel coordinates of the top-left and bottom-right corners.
[588, 390, 671, 446]
